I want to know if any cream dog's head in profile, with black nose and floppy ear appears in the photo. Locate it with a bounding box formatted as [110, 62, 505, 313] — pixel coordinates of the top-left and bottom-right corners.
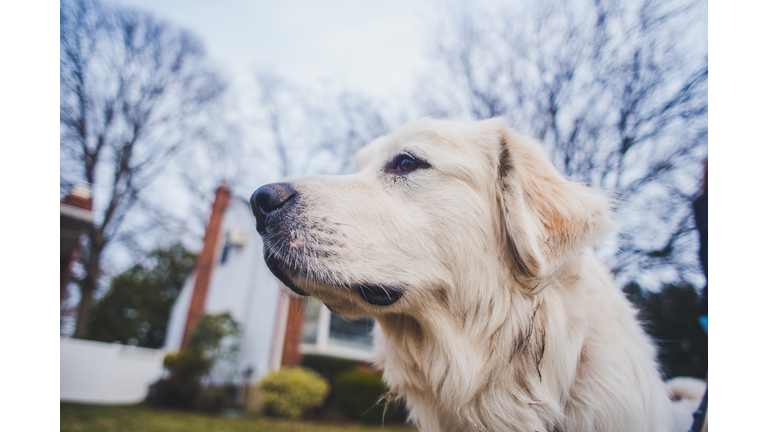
[251, 119, 609, 316]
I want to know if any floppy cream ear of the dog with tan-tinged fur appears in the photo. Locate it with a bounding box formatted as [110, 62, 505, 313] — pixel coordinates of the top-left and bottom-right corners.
[498, 128, 611, 288]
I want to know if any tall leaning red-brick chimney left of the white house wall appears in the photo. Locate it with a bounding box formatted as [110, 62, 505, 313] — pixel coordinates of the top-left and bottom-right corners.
[181, 181, 232, 346]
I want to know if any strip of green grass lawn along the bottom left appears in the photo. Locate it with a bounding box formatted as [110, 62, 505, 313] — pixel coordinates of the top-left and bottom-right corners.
[60, 403, 415, 432]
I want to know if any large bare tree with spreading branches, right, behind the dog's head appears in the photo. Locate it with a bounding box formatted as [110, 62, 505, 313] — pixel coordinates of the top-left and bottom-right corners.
[418, 0, 708, 287]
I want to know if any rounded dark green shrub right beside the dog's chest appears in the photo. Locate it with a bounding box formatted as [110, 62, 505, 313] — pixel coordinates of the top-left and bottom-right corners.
[334, 369, 395, 424]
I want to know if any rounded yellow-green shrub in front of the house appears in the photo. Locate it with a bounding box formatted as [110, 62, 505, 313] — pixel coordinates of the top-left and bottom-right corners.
[259, 367, 329, 420]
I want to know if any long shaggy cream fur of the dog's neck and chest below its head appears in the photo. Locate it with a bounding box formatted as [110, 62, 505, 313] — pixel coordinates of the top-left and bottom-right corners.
[377, 253, 668, 432]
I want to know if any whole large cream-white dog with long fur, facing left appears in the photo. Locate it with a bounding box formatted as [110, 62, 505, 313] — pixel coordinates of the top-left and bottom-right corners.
[251, 119, 704, 432]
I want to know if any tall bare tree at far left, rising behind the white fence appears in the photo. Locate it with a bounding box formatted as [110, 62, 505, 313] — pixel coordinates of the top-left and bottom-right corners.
[60, 0, 231, 337]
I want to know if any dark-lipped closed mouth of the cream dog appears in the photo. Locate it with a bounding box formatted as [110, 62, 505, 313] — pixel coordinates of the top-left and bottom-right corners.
[264, 253, 405, 306]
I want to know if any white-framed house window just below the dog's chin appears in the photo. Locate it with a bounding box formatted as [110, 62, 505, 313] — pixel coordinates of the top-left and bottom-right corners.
[301, 298, 374, 360]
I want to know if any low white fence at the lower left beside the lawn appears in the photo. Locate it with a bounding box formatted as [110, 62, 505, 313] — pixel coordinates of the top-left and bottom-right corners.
[59, 338, 166, 404]
